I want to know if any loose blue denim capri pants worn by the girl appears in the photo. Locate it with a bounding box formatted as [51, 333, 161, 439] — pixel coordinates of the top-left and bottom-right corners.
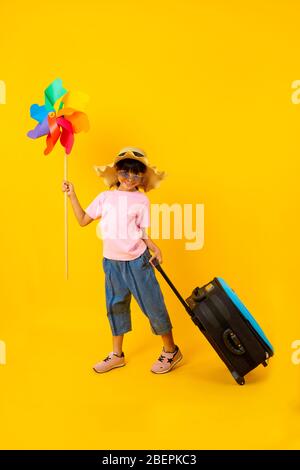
[103, 248, 172, 336]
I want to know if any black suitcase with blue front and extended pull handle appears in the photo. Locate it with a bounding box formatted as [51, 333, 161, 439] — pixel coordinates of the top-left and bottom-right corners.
[152, 259, 274, 385]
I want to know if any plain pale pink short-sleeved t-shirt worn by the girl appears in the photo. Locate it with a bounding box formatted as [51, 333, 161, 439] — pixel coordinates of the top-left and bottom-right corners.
[85, 189, 150, 261]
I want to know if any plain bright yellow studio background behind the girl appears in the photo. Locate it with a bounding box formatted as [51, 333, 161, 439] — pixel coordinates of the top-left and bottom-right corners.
[0, 0, 300, 449]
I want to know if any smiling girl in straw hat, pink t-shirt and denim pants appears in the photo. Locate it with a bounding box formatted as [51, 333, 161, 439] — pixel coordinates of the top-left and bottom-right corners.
[62, 147, 182, 374]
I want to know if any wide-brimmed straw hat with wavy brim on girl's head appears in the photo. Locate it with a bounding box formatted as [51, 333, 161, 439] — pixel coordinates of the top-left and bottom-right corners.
[94, 147, 166, 192]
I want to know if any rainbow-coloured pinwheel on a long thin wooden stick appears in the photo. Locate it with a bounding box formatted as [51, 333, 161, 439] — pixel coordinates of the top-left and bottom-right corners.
[27, 78, 89, 279]
